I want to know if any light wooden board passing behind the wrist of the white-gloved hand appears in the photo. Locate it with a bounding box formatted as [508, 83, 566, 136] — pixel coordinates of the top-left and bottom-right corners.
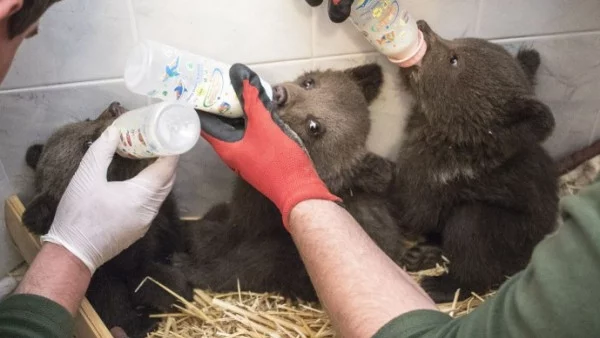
[4, 196, 112, 338]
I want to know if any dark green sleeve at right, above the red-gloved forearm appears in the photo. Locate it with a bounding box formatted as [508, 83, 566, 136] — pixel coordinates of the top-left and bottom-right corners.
[375, 183, 600, 338]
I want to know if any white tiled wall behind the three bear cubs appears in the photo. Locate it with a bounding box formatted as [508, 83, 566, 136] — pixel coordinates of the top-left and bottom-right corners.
[0, 0, 600, 276]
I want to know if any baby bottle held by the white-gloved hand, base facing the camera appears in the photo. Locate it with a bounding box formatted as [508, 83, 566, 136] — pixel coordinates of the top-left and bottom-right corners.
[113, 101, 200, 159]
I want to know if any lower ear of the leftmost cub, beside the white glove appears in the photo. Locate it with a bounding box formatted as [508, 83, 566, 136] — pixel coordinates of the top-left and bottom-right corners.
[23, 193, 59, 235]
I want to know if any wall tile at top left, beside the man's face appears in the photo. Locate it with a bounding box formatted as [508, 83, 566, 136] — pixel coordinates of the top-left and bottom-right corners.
[2, 0, 133, 88]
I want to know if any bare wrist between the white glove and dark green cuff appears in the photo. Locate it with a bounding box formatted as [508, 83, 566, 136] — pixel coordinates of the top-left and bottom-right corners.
[15, 243, 91, 315]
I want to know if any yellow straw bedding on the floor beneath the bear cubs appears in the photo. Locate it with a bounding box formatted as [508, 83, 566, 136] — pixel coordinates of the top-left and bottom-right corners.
[146, 156, 600, 338]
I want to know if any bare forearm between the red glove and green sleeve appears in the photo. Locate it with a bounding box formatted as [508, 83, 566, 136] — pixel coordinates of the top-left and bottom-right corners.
[290, 200, 436, 337]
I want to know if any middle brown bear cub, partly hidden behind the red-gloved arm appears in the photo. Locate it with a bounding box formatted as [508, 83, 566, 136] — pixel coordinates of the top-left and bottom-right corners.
[181, 64, 435, 300]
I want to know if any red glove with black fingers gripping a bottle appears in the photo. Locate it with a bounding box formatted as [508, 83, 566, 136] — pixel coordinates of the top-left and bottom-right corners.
[200, 64, 340, 229]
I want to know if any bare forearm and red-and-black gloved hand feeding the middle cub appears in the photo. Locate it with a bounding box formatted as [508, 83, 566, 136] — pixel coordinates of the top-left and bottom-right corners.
[201, 65, 435, 337]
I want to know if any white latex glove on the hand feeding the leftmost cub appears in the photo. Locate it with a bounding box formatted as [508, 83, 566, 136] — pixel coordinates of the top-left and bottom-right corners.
[42, 127, 179, 274]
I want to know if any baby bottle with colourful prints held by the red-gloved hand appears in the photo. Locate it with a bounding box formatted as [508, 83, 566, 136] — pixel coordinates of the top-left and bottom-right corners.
[125, 40, 273, 118]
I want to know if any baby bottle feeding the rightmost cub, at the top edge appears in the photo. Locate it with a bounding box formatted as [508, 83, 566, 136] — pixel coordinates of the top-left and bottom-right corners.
[350, 0, 427, 67]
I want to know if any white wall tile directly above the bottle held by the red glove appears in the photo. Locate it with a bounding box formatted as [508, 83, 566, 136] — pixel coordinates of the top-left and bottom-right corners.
[132, 0, 311, 63]
